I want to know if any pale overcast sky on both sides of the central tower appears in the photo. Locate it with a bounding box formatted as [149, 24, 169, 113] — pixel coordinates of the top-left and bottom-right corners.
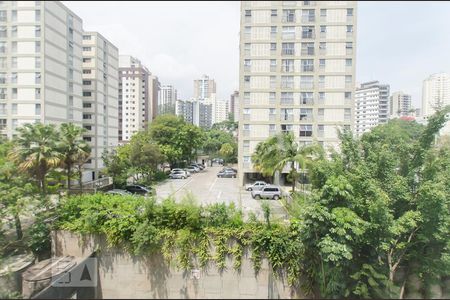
[63, 1, 450, 107]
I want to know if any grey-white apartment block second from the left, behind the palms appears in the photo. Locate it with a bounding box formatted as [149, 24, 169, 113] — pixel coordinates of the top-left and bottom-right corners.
[82, 32, 119, 180]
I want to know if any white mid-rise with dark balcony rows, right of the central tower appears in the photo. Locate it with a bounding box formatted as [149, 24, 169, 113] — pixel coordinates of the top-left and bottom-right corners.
[355, 81, 390, 136]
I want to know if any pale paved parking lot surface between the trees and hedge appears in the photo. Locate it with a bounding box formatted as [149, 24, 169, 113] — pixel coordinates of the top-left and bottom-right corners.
[155, 167, 286, 219]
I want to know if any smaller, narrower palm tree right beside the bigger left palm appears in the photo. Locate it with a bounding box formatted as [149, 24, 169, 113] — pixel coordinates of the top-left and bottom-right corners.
[59, 123, 91, 190]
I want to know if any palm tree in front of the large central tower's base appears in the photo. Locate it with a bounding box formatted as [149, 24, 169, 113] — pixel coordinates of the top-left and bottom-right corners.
[252, 132, 319, 192]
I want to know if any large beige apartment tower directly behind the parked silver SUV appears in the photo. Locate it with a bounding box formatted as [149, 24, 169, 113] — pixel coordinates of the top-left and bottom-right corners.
[238, 1, 356, 184]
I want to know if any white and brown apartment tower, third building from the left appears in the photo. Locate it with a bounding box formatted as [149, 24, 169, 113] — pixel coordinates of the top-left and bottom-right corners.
[119, 55, 153, 141]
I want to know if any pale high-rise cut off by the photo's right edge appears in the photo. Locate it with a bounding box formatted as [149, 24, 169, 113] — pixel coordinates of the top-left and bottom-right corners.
[422, 73, 450, 118]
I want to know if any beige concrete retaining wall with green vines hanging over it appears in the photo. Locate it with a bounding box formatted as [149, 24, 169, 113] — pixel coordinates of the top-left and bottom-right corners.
[52, 231, 305, 299]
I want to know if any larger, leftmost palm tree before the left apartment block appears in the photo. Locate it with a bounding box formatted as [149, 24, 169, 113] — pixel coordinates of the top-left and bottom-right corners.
[9, 123, 61, 195]
